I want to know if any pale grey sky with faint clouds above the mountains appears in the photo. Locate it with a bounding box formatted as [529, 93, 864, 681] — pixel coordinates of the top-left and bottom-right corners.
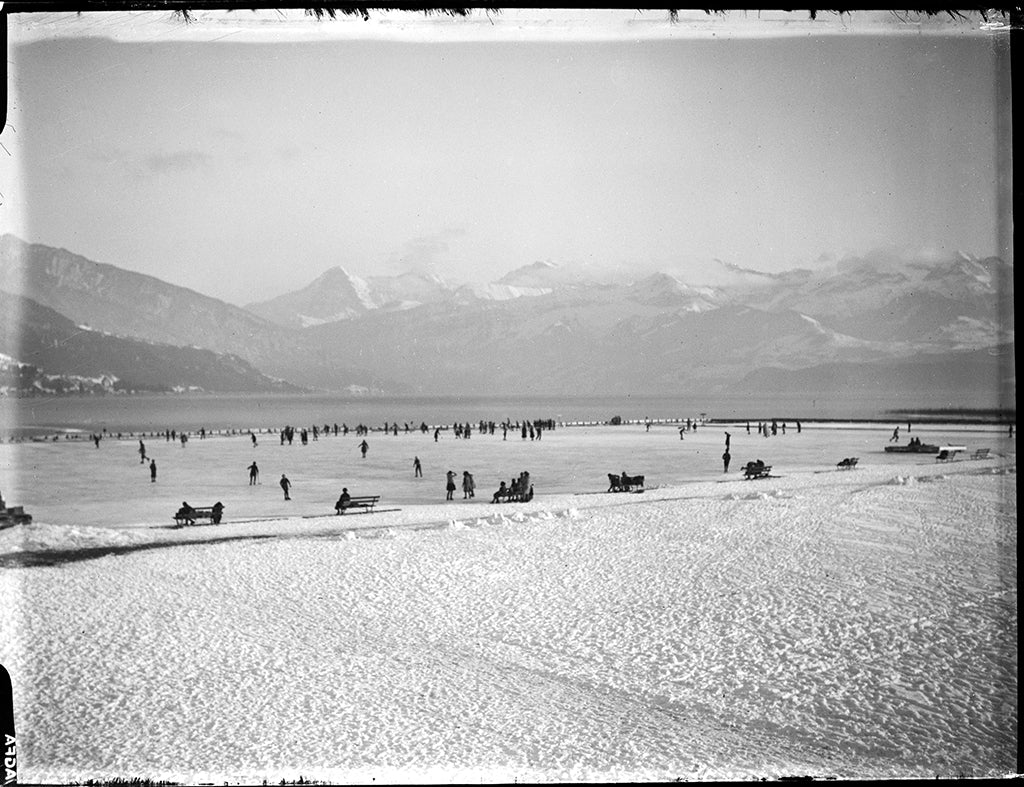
[0, 9, 1011, 305]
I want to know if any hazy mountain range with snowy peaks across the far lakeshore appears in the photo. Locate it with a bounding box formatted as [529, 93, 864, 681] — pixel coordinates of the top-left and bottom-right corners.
[0, 234, 1016, 406]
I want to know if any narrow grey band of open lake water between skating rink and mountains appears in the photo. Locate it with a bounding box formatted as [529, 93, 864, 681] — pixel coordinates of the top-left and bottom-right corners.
[0, 392, 1016, 439]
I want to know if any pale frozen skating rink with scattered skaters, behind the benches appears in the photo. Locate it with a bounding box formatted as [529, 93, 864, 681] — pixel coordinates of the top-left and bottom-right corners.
[0, 422, 1014, 526]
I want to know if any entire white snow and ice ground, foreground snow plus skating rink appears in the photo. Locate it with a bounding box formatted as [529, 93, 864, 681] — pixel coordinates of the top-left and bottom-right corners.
[0, 425, 1018, 783]
